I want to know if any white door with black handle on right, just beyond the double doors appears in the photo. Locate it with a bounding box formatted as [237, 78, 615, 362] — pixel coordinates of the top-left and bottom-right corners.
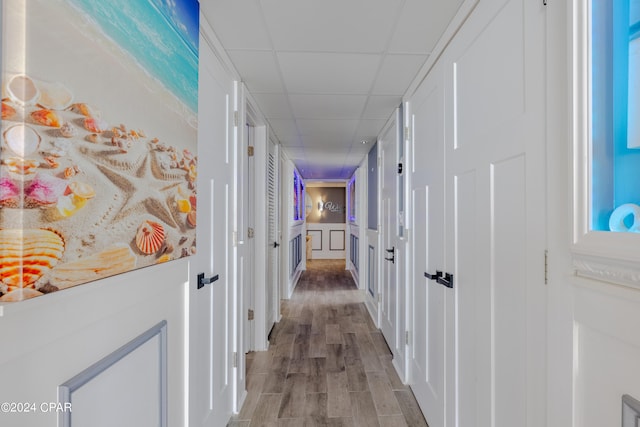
[379, 114, 398, 358]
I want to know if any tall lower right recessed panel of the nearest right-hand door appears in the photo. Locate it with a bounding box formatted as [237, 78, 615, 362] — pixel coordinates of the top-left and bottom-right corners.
[491, 155, 524, 426]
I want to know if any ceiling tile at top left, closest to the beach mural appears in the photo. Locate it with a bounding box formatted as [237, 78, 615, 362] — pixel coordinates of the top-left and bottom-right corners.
[200, 0, 272, 50]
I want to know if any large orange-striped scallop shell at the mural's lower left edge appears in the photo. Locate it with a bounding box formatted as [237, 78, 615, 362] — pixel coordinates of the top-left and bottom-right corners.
[0, 228, 64, 291]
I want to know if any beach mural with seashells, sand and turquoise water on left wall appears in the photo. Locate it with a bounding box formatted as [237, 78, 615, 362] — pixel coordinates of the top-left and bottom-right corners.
[0, 0, 199, 302]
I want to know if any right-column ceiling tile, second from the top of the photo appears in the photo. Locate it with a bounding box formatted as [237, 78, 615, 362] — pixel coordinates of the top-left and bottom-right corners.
[371, 55, 428, 95]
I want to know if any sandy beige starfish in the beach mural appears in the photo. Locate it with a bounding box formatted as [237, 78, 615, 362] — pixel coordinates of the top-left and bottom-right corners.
[96, 153, 183, 228]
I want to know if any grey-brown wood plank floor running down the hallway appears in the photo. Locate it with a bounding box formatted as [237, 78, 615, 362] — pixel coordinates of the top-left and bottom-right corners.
[229, 260, 428, 427]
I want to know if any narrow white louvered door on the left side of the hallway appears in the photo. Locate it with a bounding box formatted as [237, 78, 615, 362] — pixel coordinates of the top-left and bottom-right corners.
[266, 140, 280, 333]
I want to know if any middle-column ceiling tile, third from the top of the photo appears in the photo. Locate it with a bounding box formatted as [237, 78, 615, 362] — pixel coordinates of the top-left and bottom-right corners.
[289, 95, 367, 119]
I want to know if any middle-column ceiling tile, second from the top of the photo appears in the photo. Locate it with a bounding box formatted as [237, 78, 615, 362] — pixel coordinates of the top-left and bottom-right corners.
[277, 52, 381, 94]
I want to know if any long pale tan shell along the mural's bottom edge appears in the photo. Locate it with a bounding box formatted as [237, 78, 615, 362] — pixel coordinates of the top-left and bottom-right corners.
[49, 243, 136, 289]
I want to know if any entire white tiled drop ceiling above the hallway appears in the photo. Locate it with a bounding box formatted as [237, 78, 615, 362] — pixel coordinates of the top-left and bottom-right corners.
[200, 0, 463, 179]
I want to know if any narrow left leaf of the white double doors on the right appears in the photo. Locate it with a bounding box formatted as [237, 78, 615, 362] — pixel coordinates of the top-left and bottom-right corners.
[409, 63, 453, 426]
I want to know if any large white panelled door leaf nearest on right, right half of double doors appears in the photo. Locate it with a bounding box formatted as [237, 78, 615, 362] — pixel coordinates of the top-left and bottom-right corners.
[444, 0, 546, 427]
